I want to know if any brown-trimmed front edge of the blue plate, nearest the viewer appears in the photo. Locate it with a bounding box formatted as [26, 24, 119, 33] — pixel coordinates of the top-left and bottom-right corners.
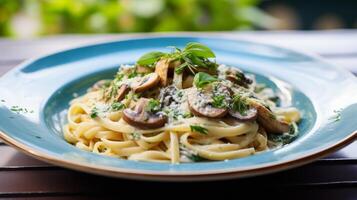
[0, 130, 357, 181]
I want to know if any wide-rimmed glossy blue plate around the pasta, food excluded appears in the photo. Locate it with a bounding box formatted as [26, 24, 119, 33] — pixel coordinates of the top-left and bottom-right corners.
[0, 37, 357, 180]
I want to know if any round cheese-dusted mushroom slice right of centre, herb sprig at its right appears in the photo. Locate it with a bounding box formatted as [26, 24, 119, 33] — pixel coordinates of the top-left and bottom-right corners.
[187, 89, 228, 118]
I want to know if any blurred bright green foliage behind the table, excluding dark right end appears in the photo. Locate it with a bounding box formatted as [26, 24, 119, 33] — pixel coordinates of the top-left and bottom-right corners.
[0, 0, 268, 36]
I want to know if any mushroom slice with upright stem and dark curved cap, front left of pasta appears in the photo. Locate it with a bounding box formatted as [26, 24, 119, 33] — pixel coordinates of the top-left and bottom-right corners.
[123, 98, 167, 129]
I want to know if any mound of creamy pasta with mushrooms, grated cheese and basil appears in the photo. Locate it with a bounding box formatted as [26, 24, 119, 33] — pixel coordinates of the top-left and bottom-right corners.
[63, 42, 301, 164]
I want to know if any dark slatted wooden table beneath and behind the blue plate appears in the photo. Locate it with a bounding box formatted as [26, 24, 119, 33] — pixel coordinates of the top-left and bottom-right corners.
[0, 30, 357, 199]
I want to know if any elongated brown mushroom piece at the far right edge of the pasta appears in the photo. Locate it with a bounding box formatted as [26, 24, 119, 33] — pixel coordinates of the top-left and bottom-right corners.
[249, 99, 290, 133]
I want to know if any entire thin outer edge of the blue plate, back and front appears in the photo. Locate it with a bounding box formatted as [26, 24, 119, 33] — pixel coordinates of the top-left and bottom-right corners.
[0, 34, 357, 181]
